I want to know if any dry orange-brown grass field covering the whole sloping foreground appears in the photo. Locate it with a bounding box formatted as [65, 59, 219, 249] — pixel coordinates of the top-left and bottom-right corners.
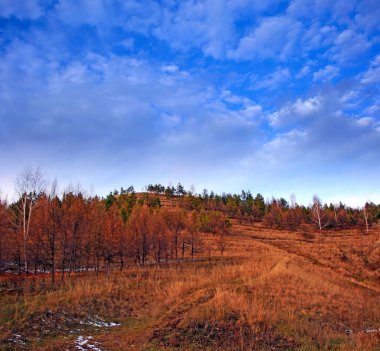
[0, 223, 380, 351]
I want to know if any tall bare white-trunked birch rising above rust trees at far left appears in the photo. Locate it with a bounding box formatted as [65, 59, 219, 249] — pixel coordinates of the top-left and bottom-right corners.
[16, 167, 46, 274]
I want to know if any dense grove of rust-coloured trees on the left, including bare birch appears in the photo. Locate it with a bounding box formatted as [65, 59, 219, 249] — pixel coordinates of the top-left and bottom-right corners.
[0, 169, 229, 283]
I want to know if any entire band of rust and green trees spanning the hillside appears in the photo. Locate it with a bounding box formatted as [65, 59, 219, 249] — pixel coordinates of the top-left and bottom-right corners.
[0, 169, 380, 284]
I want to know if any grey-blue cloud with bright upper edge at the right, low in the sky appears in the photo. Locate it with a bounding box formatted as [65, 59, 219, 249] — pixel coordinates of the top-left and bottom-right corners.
[267, 91, 380, 169]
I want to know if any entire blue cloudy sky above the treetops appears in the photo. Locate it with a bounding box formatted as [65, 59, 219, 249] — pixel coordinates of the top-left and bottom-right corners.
[0, 0, 380, 206]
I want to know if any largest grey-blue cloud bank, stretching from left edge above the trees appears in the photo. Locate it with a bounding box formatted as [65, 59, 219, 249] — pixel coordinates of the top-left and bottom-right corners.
[0, 43, 268, 194]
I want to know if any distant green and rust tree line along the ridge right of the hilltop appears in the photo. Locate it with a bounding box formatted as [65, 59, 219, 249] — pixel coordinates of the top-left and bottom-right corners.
[154, 185, 380, 232]
